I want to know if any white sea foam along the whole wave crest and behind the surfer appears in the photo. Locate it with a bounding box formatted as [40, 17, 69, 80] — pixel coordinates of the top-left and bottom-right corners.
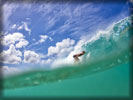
[52, 16, 131, 68]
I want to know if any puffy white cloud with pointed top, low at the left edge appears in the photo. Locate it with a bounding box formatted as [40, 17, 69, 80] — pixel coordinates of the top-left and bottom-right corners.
[0, 44, 22, 64]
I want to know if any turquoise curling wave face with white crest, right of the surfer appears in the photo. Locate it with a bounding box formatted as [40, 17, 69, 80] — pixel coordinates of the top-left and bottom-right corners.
[83, 17, 132, 61]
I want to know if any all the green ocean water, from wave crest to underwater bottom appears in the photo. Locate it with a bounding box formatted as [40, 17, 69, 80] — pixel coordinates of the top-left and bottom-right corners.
[3, 16, 133, 97]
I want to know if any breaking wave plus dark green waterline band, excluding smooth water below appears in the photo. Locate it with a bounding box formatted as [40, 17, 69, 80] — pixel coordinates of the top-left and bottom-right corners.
[4, 16, 133, 89]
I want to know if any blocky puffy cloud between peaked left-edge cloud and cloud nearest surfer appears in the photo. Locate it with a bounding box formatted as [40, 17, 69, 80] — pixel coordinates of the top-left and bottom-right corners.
[24, 50, 42, 63]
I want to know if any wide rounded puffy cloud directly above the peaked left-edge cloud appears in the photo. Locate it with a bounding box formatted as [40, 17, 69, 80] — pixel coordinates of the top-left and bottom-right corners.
[1, 32, 28, 48]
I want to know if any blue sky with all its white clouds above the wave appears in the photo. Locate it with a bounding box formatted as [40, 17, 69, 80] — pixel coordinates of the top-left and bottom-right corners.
[0, 1, 129, 74]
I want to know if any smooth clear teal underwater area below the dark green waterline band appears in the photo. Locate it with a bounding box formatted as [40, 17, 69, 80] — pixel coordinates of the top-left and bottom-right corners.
[4, 63, 130, 97]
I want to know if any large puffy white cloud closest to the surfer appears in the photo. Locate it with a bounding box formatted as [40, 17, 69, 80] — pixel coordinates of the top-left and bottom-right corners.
[48, 38, 75, 56]
